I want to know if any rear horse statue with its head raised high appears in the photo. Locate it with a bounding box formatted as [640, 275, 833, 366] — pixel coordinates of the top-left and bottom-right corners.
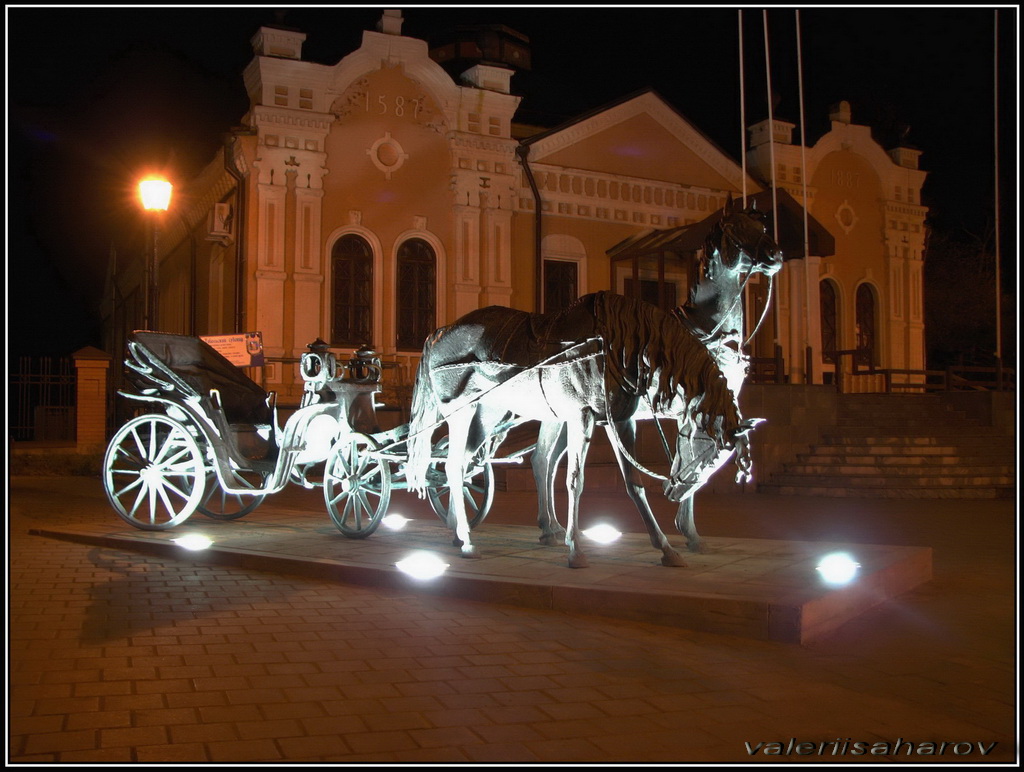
[532, 198, 782, 552]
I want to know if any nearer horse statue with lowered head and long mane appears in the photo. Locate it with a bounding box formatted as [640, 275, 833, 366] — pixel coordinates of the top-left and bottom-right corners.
[406, 292, 770, 567]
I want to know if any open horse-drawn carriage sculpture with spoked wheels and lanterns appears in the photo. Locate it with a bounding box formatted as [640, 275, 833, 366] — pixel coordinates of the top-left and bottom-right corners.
[102, 331, 531, 539]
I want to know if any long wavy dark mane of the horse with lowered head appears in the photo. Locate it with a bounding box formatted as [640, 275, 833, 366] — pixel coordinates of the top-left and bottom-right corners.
[594, 292, 740, 441]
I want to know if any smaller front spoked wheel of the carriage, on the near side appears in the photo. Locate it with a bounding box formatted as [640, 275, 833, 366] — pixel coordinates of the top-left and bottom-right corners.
[324, 432, 391, 539]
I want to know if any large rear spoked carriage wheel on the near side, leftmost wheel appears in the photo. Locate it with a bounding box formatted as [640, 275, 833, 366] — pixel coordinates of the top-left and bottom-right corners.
[103, 414, 206, 530]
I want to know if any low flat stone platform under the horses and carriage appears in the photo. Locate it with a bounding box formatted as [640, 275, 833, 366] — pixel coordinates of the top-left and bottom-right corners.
[34, 508, 932, 643]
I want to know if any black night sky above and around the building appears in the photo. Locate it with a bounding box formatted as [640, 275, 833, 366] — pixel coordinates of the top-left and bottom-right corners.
[6, 5, 1019, 358]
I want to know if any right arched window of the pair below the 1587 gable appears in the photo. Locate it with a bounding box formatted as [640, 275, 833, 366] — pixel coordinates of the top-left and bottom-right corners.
[395, 239, 437, 351]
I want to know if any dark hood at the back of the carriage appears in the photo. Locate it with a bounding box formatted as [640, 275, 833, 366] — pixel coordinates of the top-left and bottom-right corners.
[129, 331, 272, 426]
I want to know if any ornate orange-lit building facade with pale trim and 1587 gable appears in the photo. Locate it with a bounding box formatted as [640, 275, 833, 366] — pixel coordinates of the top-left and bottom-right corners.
[109, 11, 927, 403]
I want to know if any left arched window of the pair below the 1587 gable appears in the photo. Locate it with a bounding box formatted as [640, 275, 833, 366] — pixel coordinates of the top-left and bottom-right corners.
[331, 234, 374, 346]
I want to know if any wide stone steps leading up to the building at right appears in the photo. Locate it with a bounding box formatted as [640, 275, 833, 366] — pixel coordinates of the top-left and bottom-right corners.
[758, 394, 1016, 499]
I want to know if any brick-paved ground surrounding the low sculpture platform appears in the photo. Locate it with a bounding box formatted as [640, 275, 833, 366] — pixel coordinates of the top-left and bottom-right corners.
[8, 477, 1017, 764]
